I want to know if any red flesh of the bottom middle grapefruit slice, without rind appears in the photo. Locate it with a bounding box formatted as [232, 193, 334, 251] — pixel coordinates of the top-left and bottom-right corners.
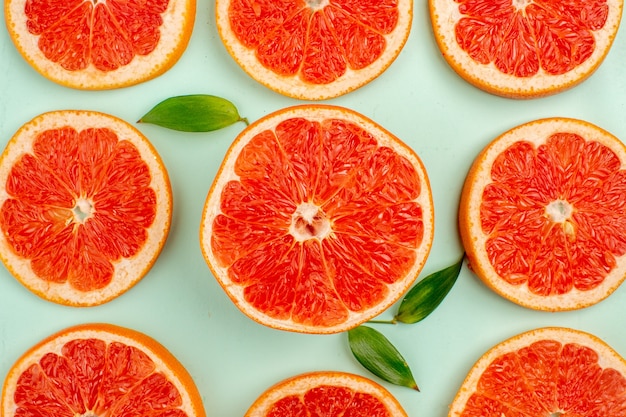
[266, 385, 391, 417]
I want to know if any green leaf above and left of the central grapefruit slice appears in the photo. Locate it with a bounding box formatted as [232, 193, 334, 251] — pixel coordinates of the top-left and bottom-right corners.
[138, 94, 248, 132]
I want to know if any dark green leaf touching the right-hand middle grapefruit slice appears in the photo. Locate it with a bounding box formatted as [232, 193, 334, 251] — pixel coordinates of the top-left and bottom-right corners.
[394, 256, 464, 324]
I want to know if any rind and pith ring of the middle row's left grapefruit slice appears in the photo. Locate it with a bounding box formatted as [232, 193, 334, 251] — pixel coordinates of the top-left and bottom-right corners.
[0, 110, 172, 307]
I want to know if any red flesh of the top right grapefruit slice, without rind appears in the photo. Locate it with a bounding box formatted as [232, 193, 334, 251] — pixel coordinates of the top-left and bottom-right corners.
[455, 0, 609, 77]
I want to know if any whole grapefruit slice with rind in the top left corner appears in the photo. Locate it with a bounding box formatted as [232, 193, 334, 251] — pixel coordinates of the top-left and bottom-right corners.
[4, 0, 196, 90]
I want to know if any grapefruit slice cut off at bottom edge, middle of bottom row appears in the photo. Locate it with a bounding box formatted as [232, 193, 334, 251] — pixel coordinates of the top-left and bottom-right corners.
[244, 371, 407, 417]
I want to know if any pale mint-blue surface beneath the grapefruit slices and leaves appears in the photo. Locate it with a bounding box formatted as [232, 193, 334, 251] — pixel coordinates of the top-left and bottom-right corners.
[0, 0, 626, 417]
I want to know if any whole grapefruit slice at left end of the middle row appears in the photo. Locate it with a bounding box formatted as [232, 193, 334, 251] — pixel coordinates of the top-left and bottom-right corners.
[0, 110, 172, 306]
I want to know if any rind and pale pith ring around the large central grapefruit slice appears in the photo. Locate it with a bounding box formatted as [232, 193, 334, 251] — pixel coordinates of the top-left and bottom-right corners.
[200, 104, 434, 333]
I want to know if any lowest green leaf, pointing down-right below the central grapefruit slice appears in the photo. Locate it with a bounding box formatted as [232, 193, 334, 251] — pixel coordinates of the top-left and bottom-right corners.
[348, 326, 419, 391]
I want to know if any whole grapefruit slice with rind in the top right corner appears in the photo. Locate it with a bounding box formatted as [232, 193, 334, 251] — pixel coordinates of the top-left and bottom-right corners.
[429, 0, 624, 98]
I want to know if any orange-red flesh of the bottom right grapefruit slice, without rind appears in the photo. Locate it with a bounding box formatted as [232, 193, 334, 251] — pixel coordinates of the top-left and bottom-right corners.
[461, 340, 626, 417]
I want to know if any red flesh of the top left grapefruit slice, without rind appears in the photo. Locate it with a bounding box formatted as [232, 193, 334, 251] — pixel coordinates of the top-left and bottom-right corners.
[24, 0, 169, 71]
